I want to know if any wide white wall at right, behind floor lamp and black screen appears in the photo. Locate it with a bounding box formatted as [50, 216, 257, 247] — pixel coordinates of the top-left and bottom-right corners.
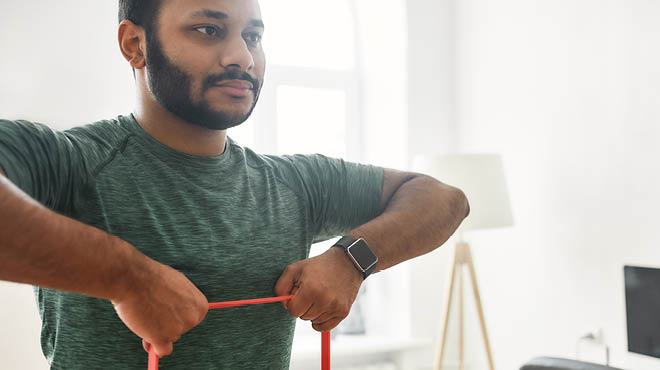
[409, 0, 660, 370]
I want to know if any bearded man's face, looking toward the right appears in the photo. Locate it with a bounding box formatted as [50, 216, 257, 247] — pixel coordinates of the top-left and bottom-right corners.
[146, 0, 266, 130]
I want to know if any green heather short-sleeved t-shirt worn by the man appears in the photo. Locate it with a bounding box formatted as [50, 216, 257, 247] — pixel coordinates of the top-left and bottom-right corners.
[0, 116, 383, 370]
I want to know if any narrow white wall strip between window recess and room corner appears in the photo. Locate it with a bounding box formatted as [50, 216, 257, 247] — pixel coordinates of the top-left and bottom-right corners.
[405, 0, 458, 370]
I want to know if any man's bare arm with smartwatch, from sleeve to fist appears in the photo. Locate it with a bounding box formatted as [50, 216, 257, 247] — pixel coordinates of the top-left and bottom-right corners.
[275, 170, 469, 331]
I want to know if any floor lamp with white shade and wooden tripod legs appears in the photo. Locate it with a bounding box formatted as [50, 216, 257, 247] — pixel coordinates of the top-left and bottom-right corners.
[413, 154, 513, 370]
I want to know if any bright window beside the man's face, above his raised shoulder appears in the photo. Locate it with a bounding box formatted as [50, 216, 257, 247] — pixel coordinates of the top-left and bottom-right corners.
[229, 0, 362, 161]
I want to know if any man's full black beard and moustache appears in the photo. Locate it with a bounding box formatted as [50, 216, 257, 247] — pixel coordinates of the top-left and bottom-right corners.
[146, 32, 262, 130]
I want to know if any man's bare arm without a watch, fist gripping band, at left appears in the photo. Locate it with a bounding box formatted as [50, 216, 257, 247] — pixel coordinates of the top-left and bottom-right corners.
[0, 168, 207, 356]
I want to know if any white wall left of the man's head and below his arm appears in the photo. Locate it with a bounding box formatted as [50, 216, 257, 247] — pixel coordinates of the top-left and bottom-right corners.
[0, 0, 133, 370]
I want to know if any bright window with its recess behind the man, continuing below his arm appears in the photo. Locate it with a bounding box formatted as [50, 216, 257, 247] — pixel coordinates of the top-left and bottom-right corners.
[229, 0, 410, 340]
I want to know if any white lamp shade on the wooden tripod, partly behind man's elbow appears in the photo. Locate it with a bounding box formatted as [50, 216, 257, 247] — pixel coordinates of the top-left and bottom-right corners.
[413, 154, 513, 231]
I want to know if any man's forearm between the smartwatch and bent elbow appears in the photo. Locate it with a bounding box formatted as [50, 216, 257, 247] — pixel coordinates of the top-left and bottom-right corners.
[349, 175, 469, 271]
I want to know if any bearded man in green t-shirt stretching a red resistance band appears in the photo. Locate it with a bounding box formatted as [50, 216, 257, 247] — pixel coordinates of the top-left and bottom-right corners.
[0, 0, 468, 370]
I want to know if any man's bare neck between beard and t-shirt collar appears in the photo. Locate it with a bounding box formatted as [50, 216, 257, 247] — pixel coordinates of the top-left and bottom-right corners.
[133, 92, 227, 157]
